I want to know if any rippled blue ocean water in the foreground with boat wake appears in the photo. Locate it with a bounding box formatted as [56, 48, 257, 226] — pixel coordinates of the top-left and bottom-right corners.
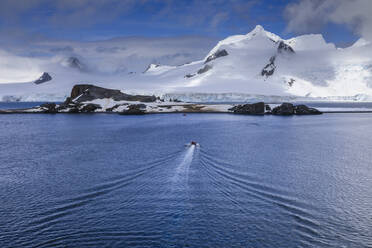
[0, 114, 372, 248]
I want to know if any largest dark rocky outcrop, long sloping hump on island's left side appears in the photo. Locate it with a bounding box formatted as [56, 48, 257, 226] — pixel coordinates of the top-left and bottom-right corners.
[70, 84, 156, 102]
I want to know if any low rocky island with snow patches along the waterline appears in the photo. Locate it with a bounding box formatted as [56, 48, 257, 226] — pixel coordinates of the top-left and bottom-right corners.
[0, 84, 322, 115]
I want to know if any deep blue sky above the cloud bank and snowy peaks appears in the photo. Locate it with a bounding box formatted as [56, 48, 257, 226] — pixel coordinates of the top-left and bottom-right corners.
[0, 0, 364, 46]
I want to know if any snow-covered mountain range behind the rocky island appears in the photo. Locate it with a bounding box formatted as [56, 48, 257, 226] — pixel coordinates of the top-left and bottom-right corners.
[0, 26, 372, 101]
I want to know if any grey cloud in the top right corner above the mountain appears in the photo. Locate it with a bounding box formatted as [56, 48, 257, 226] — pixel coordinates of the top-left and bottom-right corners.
[285, 0, 372, 41]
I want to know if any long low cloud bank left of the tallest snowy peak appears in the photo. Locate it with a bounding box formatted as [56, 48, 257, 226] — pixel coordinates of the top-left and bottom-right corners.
[0, 36, 217, 84]
